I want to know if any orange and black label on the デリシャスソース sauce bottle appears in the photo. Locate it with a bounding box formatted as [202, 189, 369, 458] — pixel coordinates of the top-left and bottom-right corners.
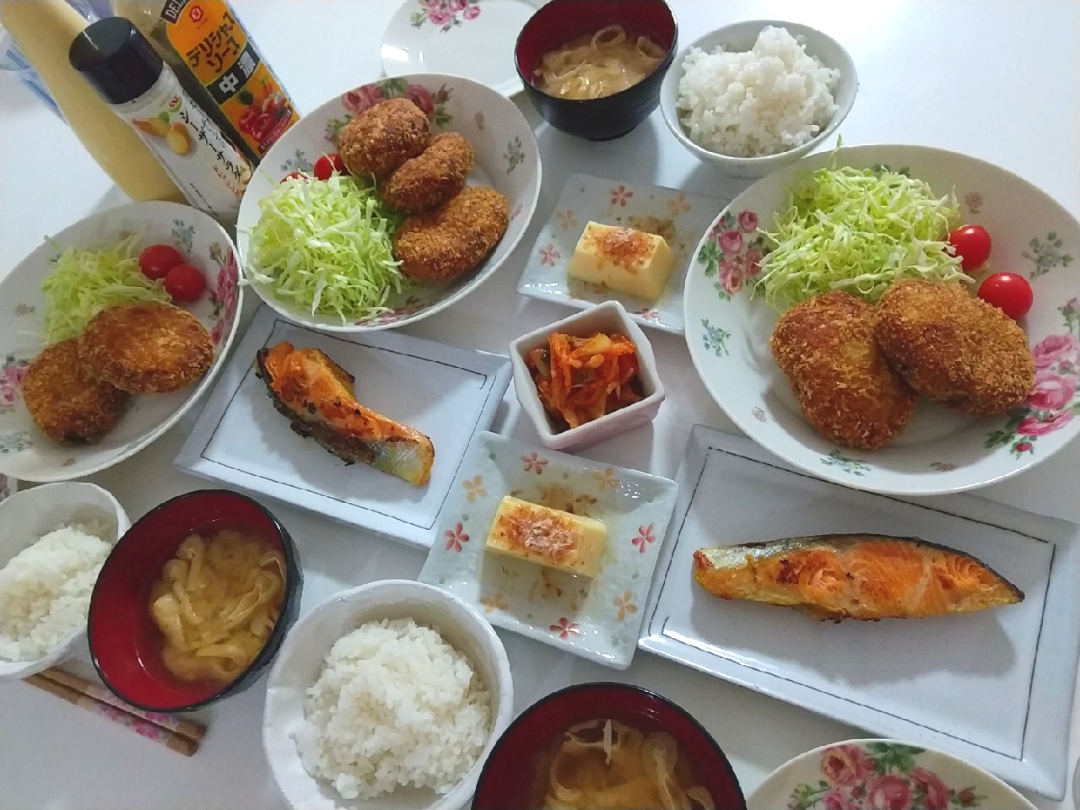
[161, 0, 300, 158]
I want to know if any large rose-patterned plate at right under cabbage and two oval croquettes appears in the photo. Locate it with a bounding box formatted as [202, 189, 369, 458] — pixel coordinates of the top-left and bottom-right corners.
[684, 146, 1080, 496]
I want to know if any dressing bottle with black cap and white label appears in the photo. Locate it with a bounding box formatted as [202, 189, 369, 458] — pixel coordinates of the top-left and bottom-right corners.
[69, 17, 252, 225]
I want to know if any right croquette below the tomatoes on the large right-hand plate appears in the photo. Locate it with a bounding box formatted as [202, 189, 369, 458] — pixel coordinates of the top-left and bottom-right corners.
[875, 279, 1035, 416]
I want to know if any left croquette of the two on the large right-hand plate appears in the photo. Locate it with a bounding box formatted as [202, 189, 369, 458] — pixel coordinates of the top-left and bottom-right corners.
[770, 292, 915, 450]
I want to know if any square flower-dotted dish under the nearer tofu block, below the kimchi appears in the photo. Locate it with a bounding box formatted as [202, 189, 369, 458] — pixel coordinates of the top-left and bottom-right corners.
[419, 432, 678, 670]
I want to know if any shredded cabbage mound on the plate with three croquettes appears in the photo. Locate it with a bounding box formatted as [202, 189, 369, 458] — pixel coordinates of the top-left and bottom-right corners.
[251, 175, 408, 323]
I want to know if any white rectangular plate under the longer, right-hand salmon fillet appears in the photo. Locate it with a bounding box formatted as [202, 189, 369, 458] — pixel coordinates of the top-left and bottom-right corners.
[640, 424, 1080, 798]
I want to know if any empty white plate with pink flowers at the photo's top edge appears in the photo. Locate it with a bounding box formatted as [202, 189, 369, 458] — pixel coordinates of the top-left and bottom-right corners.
[381, 0, 542, 97]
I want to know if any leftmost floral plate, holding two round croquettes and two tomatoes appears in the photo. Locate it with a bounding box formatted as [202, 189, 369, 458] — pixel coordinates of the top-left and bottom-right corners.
[0, 202, 243, 482]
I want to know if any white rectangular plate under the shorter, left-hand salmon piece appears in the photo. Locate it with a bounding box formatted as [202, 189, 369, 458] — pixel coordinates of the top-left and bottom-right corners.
[176, 306, 510, 549]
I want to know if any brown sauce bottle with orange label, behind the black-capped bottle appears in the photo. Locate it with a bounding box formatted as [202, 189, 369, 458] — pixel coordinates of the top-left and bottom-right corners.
[112, 0, 299, 163]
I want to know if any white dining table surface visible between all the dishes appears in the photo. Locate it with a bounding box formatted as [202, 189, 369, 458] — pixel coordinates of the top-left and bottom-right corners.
[0, 0, 1080, 810]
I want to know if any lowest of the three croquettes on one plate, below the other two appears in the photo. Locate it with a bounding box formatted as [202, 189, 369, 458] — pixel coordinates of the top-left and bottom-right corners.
[394, 187, 510, 281]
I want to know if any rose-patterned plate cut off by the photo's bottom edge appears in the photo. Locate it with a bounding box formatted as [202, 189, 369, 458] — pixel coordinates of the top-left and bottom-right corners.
[746, 740, 1036, 810]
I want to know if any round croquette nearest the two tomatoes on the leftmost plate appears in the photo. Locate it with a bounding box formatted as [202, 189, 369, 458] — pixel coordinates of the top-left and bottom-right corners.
[79, 303, 214, 394]
